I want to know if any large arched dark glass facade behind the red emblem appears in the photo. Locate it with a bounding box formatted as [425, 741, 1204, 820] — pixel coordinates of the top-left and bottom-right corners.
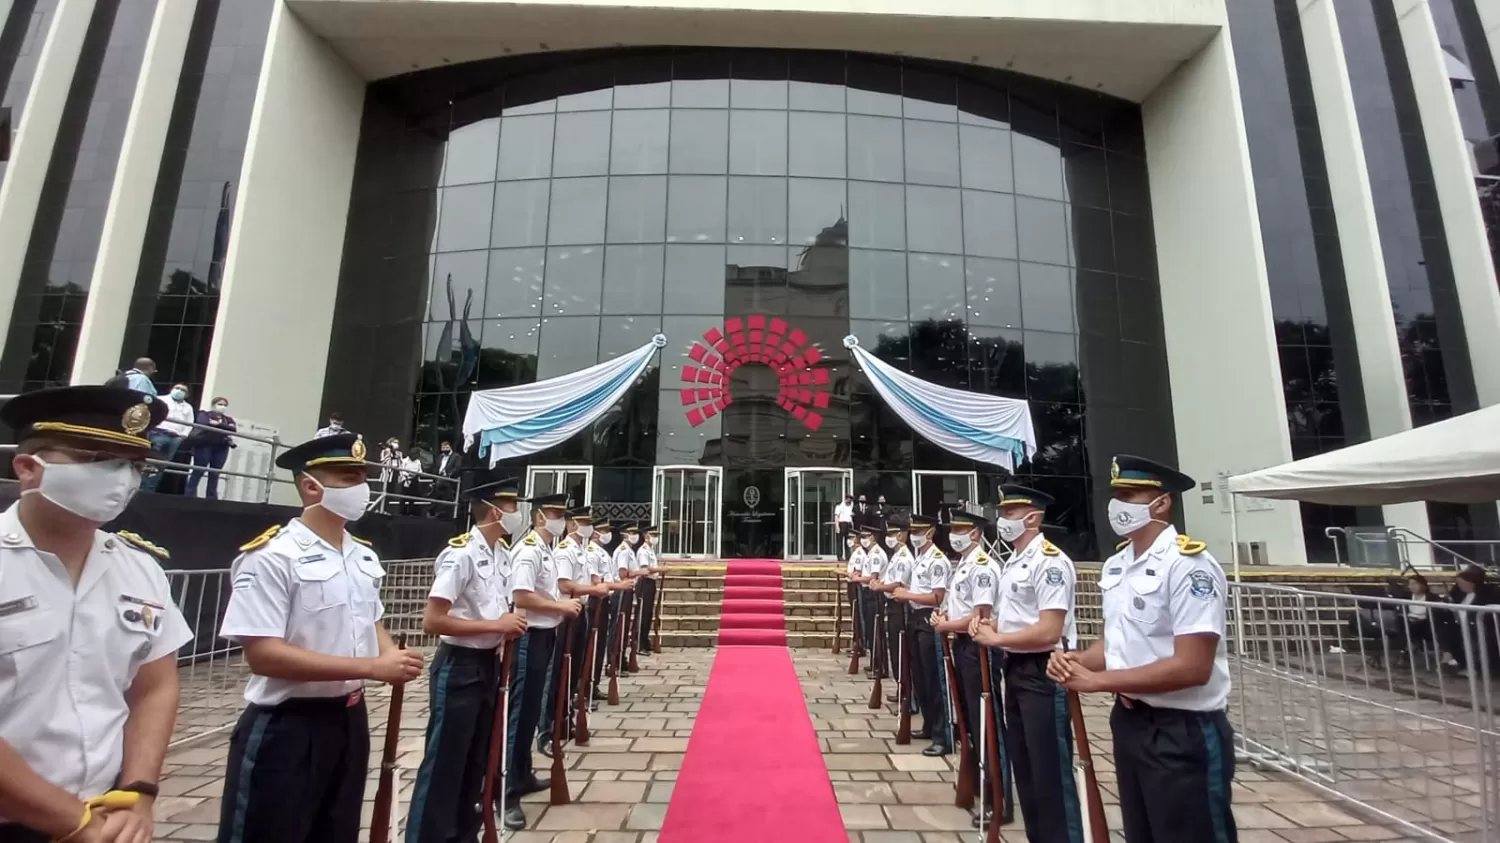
[324, 50, 1175, 558]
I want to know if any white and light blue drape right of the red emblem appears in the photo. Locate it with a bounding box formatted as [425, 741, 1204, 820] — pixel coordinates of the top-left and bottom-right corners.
[845, 336, 1037, 471]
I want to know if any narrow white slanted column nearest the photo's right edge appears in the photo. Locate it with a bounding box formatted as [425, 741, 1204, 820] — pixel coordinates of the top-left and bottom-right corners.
[1394, 0, 1500, 407]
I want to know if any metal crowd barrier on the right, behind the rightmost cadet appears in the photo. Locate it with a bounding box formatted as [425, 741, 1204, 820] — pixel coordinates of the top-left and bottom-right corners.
[1229, 584, 1500, 842]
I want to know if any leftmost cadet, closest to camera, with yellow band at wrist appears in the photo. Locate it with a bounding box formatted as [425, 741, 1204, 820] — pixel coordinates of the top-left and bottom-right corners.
[0, 387, 192, 843]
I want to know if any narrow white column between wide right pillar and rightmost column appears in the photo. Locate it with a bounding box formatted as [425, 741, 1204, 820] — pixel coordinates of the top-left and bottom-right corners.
[1299, 0, 1431, 564]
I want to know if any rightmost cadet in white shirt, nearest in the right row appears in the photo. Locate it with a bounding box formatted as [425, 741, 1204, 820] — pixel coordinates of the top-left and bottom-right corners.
[1049, 455, 1238, 843]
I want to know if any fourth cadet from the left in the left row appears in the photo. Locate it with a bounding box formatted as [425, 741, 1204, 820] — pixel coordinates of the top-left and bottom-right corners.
[504, 495, 582, 831]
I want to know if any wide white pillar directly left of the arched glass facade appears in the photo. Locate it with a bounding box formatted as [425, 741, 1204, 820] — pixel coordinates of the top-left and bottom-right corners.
[204, 2, 365, 494]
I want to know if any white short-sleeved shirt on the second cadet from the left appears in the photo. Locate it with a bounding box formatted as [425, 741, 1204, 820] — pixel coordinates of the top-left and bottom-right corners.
[219, 518, 386, 705]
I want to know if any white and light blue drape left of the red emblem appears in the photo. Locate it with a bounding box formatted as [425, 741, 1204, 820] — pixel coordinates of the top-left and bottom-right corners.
[464, 335, 666, 467]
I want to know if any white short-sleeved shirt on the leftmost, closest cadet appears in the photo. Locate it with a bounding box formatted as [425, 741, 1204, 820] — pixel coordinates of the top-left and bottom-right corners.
[0, 504, 192, 822]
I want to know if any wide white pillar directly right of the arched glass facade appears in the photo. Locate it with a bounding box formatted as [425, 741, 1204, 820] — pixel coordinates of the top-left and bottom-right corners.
[1142, 29, 1307, 564]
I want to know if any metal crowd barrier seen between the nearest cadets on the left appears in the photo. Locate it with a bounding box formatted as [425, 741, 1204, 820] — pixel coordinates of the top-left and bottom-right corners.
[165, 560, 437, 747]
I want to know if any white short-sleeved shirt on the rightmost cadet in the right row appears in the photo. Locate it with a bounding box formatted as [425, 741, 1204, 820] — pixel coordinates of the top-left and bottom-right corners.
[1100, 527, 1230, 711]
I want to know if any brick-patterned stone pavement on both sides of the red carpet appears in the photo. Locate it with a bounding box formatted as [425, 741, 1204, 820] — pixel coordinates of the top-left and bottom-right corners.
[156, 650, 1452, 843]
